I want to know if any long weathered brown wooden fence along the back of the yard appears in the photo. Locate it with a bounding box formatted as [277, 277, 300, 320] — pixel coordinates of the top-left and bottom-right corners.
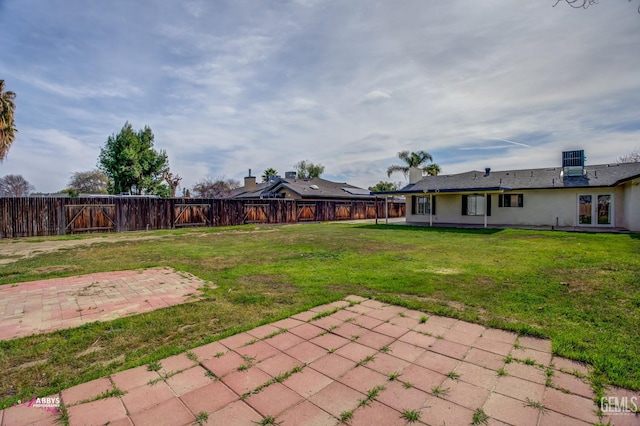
[0, 197, 405, 238]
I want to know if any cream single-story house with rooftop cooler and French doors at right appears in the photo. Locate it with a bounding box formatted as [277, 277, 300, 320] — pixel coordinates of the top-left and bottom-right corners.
[375, 150, 640, 232]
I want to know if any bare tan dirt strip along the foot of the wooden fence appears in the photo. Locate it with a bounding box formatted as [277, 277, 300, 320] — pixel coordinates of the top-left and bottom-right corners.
[0, 235, 162, 265]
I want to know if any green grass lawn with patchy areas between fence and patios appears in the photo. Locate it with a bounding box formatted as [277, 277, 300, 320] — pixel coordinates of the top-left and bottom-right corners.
[0, 223, 640, 407]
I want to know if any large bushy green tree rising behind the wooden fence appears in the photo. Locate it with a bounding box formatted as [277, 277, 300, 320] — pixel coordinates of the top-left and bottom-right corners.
[98, 122, 171, 197]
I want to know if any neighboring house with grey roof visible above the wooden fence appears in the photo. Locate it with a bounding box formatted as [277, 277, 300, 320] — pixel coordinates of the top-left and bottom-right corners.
[231, 172, 375, 201]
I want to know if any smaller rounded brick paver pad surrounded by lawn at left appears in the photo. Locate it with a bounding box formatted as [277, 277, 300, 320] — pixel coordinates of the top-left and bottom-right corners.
[0, 268, 204, 340]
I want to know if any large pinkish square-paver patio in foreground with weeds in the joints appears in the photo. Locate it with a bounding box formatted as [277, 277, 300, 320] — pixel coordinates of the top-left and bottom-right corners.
[0, 296, 640, 426]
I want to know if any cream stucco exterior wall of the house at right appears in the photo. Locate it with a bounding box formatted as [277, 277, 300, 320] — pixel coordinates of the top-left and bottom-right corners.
[406, 185, 640, 230]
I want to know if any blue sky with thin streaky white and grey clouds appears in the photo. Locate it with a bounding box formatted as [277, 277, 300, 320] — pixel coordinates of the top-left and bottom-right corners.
[0, 0, 640, 192]
